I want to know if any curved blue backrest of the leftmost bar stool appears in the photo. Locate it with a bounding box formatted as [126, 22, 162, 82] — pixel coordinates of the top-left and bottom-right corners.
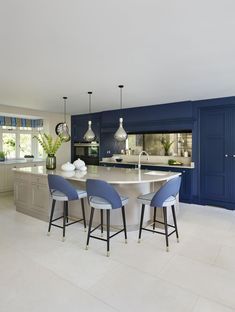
[48, 174, 78, 200]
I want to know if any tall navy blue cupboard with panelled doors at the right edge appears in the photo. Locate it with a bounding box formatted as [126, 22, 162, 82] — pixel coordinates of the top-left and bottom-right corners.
[200, 106, 235, 209]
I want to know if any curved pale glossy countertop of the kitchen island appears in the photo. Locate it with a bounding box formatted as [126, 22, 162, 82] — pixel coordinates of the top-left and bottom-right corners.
[14, 166, 181, 184]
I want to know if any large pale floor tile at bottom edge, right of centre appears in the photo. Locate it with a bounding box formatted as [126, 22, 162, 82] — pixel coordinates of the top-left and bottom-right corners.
[89, 265, 197, 312]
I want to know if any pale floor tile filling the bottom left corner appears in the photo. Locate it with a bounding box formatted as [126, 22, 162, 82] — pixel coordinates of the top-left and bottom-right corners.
[0, 249, 116, 312]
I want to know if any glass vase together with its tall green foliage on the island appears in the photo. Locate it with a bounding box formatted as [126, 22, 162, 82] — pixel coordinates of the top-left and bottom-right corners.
[34, 133, 64, 170]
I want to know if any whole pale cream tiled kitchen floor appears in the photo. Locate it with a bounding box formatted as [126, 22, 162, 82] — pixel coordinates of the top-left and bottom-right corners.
[0, 196, 235, 312]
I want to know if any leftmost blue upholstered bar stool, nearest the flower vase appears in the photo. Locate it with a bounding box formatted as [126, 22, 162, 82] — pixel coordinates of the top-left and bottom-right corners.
[48, 174, 87, 241]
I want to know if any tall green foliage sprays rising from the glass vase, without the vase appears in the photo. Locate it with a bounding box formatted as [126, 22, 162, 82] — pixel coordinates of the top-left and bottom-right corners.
[34, 133, 64, 155]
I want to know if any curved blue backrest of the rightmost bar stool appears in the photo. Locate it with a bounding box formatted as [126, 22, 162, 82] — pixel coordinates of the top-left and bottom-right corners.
[150, 176, 181, 207]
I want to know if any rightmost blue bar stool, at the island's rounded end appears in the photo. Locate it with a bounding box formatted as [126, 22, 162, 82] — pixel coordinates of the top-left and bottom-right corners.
[138, 176, 181, 251]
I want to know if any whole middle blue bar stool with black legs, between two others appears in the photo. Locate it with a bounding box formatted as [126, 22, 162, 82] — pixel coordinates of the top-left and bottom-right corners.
[86, 179, 128, 257]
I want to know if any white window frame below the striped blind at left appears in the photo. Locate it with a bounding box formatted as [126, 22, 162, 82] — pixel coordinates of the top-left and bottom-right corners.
[0, 127, 43, 159]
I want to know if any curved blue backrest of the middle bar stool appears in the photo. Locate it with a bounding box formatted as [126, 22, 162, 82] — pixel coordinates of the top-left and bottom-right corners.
[86, 179, 122, 209]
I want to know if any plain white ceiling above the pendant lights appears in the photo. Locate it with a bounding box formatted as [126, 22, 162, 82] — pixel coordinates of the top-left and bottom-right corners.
[0, 0, 235, 114]
